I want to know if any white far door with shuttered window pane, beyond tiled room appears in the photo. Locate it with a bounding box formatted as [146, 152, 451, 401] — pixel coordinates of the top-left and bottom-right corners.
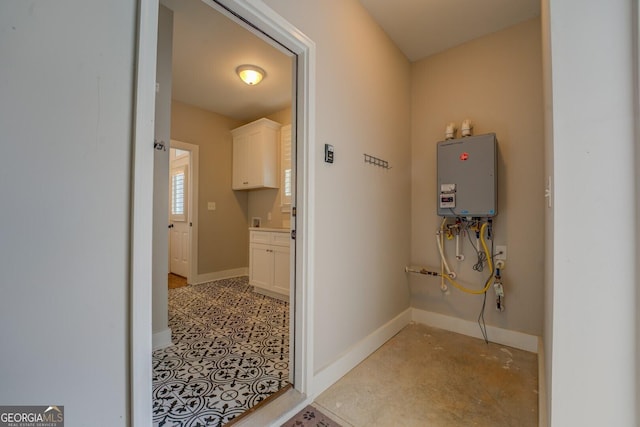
[169, 148, 191, 277]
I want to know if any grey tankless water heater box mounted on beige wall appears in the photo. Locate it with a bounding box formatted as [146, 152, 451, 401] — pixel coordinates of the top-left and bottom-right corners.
[437, 133, 498, 218]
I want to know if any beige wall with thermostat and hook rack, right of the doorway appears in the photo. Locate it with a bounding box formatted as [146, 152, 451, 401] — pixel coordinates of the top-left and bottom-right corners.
[265, 0, 411, 372]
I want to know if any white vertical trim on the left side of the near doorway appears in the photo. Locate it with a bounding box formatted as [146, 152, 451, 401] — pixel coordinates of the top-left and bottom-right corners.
[131, 0, 158, 427]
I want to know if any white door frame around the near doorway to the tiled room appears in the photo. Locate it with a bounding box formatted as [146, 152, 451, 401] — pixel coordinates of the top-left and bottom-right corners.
[129, 0, 316, 427]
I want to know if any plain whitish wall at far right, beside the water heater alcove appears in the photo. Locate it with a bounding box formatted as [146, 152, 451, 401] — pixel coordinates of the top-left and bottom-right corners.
[543, 0, 640, 426]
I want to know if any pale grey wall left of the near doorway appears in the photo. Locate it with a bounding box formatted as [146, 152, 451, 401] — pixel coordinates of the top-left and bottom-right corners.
[0, 0, 136, 426]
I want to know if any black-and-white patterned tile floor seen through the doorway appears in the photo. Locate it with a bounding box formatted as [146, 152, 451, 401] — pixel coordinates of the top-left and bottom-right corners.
[153, 277, 289, 426]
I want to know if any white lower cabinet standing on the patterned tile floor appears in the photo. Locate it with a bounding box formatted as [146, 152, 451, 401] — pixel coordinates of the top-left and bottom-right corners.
[249, 229, 290, 300]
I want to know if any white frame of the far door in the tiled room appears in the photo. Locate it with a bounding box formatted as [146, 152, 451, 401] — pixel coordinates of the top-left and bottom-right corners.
[169, 139, 200, 284]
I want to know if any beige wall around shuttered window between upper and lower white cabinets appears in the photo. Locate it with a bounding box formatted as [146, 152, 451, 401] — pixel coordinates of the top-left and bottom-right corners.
[248, 107, 291, 228]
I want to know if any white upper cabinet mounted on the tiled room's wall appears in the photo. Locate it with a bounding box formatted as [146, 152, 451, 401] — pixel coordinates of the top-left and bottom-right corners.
[231, 119, 280, 190]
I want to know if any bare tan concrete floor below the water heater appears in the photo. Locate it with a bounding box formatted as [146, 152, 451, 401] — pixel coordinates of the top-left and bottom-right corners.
[314, 324, 538, 427]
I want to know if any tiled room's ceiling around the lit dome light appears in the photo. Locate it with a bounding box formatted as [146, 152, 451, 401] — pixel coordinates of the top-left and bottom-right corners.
[161, 0, 293, 121]
